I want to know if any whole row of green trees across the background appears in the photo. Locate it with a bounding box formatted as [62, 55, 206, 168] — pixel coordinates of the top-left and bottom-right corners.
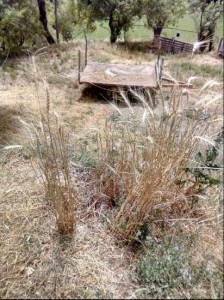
[0, 0, 223, 53]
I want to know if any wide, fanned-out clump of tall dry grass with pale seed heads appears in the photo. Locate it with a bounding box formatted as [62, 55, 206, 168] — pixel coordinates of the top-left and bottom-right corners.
[93, 87, 221, 242]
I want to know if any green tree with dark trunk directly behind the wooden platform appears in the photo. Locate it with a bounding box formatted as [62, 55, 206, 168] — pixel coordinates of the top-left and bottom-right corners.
[85, 0, 142, 43]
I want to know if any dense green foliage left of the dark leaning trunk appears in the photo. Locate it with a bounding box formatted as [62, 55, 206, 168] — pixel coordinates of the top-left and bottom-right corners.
[0, 0, 41, 53]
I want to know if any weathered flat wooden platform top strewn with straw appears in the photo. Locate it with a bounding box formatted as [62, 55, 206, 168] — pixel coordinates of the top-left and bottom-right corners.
[79, 63, 158, 88]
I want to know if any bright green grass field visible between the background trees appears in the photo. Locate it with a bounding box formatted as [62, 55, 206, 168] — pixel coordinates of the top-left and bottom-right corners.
[85, 15, 223, 43]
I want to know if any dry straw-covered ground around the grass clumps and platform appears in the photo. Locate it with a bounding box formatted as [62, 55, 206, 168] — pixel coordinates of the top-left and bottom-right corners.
[0, 42, 223, 298]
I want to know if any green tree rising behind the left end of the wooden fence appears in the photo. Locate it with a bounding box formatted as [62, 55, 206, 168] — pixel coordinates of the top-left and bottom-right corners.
[143, 0, 186, 37]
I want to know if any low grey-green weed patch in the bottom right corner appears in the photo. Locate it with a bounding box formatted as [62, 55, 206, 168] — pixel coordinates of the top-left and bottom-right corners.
[137, 234, 223, 299]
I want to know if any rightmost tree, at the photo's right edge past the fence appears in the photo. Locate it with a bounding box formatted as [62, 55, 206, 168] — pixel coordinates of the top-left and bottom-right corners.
[188, 0, 223, 52]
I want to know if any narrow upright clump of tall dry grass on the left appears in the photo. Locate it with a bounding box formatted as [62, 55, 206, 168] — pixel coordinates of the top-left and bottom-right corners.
[32, 59, 76, 235]
